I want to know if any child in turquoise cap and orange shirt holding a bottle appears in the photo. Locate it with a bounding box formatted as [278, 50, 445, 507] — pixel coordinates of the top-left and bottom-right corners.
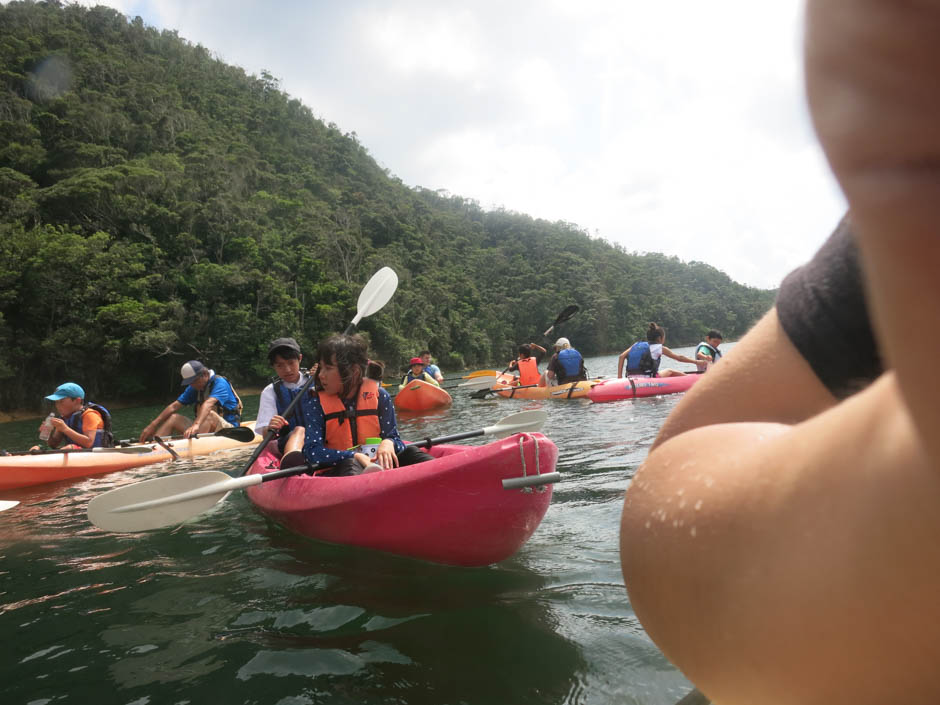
[30, 382, 114, 450]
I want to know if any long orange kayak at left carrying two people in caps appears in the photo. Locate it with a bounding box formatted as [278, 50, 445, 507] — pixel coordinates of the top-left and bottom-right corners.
[0, 421, 261, 490]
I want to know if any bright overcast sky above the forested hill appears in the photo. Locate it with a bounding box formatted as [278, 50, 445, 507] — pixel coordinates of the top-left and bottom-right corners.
[79, 0, 845, 288]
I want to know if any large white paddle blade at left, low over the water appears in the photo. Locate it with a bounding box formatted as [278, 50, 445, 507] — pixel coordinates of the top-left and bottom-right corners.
[88, 470, 261, 533]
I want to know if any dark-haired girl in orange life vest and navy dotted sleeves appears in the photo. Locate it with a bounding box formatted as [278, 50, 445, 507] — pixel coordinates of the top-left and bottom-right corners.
[301, 335, 432, 477]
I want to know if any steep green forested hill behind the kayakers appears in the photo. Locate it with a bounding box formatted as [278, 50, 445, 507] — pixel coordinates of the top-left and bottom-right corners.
[0, 2, 773, 408]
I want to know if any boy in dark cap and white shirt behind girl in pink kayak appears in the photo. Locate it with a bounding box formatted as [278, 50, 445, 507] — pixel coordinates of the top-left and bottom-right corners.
[255, 338, 317, 468]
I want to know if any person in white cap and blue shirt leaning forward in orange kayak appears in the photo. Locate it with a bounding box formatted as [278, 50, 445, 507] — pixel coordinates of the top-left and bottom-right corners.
[140, 360, 242, 443]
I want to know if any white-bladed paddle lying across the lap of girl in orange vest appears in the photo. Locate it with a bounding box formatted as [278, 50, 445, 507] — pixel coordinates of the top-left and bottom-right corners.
[88, 410, 548, 532]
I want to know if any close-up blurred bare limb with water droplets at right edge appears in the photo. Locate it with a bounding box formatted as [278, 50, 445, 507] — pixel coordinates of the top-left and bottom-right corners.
[621, 0, 940, 705]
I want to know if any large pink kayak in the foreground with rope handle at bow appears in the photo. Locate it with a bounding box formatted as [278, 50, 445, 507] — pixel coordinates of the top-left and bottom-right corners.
[247, 433, 558, 566]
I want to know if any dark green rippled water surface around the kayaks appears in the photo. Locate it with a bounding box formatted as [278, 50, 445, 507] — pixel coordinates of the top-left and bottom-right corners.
[0, 349, 712, 705]
